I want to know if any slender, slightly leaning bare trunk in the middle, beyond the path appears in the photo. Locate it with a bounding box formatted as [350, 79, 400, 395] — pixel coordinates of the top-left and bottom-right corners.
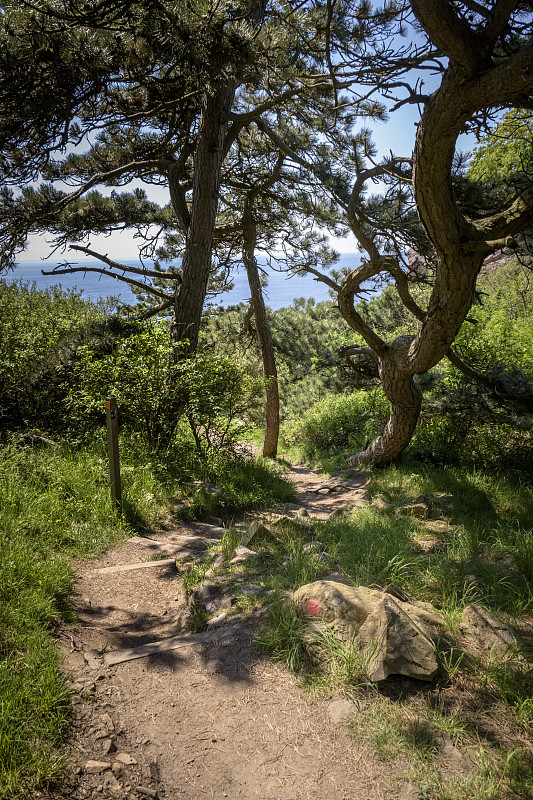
[242, 214, 279, 458]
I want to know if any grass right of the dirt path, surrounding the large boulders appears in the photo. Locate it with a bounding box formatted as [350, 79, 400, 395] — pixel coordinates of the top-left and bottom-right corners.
[246, 456, 533, 800]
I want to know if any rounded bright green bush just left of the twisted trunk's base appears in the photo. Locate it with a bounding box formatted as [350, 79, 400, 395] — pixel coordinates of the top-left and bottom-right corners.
[283, 388, 389, 456]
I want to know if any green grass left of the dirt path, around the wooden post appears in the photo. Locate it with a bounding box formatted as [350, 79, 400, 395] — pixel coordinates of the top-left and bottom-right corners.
[0, 434, 294, 800]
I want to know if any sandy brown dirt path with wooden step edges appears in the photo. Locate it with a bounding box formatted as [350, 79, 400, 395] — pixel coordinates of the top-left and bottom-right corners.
[52, 465, 407, 800]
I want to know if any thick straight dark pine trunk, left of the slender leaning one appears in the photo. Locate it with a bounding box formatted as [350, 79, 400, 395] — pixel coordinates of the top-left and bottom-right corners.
[170, 81, 235, 358]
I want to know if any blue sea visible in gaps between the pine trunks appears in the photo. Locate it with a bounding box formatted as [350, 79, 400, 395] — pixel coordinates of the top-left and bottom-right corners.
[2, 253, 360, 310]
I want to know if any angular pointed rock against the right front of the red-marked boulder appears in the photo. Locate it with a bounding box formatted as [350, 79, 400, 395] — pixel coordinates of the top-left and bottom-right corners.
[358, 595, 439, 682]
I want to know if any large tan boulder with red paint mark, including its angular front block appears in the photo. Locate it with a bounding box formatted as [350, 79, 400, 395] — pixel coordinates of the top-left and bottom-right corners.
[293, 580, 445, 681]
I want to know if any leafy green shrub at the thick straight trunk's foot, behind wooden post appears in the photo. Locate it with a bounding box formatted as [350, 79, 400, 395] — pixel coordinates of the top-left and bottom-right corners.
[68, 322, 262, 451]
